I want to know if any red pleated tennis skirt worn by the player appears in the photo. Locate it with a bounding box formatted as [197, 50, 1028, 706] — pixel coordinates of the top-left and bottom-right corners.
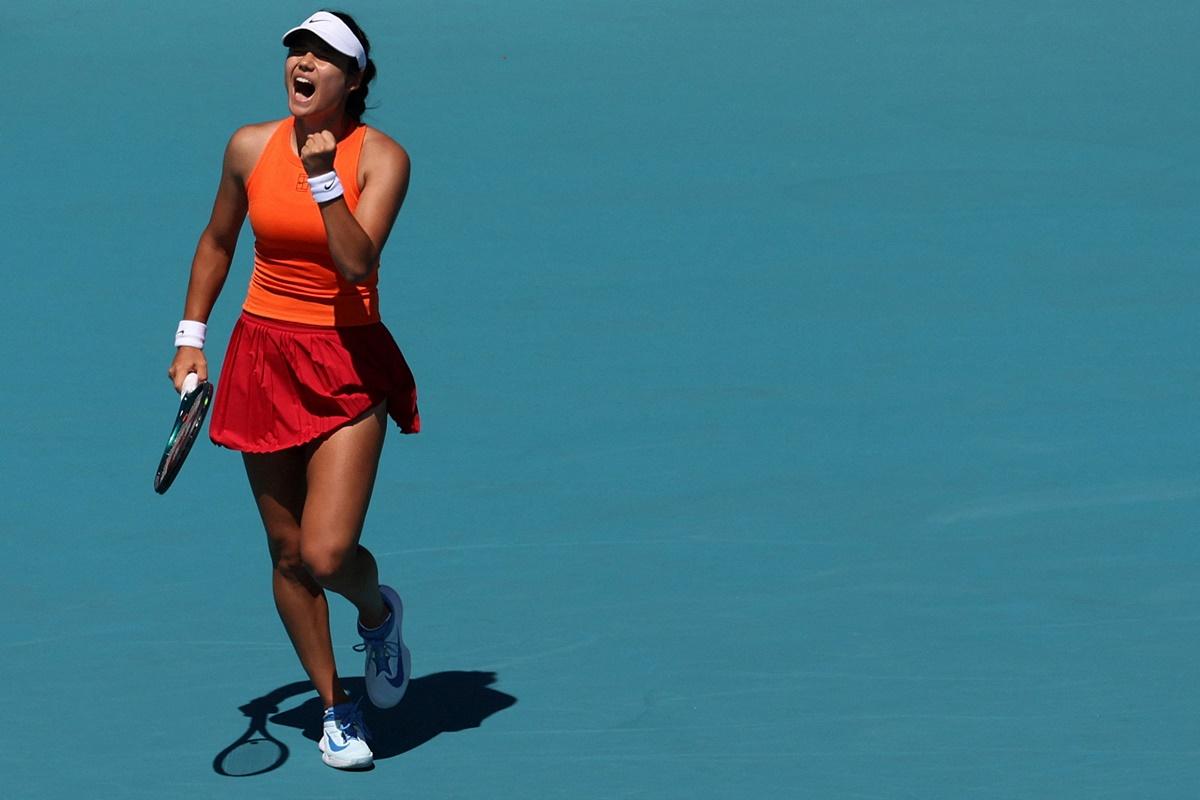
[209, 312, 421, 453]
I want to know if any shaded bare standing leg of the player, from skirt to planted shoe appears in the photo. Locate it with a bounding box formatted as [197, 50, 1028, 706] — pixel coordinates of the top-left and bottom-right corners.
[244, 449, 348, 708]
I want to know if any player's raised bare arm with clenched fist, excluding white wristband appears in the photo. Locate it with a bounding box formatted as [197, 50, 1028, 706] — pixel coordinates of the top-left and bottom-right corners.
[300, 131, 410, 283]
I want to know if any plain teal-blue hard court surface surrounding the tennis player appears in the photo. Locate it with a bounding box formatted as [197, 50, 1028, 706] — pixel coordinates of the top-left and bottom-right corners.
[0, 0, 1200, 800]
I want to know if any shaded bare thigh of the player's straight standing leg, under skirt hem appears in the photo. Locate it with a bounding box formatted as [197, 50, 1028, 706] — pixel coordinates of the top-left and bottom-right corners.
[242, 447, 307, 565]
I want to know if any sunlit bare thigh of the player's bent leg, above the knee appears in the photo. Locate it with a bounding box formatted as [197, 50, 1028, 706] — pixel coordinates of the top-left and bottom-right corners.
[304, 403, 388, 549]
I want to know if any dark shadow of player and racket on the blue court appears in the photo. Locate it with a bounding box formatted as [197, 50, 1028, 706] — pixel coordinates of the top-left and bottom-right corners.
[212, 672, 517, 777]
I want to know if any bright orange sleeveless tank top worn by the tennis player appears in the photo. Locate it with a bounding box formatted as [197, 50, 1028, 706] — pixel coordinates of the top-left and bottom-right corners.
[242, 116, 379, 327]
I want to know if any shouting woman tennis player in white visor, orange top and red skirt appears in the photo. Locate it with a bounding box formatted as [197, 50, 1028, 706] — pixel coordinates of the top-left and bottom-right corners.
[168, 11, 420, 769]
